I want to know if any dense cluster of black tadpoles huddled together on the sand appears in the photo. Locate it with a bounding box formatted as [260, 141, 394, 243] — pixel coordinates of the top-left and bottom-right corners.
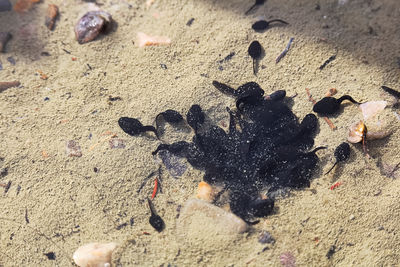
[119, 81, 324, 220]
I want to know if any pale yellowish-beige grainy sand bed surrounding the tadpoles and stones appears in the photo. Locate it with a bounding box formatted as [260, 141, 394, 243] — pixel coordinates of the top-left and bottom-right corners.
[0, 0, 400, 266]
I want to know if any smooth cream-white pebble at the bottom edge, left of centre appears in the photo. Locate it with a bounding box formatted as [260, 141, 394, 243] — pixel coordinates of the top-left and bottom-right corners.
[72, 242, 118, 267]
